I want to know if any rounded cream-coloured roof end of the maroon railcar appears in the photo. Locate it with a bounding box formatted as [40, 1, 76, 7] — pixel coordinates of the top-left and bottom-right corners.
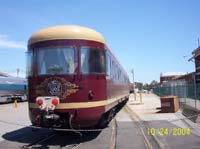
[28, 25, 106, 45]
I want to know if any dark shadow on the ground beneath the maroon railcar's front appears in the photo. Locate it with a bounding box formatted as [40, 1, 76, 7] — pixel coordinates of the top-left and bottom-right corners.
[0, 127, 102, 148]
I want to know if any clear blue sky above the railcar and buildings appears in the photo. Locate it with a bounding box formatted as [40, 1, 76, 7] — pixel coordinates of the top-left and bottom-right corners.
[0, 0, 200, 83]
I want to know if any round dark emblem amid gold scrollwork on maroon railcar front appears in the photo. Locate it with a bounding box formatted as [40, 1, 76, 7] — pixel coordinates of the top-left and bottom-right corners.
[47, 80, 62, 96]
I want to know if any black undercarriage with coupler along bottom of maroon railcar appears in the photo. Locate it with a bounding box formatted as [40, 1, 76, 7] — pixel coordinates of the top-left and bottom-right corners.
[34, 99, 128, 129]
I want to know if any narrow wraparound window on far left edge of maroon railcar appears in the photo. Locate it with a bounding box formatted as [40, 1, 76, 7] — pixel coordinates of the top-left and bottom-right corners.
[26, 51, 33, 77]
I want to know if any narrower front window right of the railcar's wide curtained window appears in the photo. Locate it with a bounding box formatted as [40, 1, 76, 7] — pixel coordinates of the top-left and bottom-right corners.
[80, 48, 106, 74]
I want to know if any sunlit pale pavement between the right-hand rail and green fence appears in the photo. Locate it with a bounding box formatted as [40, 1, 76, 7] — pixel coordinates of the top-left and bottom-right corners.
[127, 94, 200, 149]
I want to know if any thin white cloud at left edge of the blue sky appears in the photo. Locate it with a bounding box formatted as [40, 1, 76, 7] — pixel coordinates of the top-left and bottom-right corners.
[0, 34, 26, 50]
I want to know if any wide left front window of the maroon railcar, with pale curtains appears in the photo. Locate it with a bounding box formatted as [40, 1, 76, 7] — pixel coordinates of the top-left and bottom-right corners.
[37, 47, 75, 75]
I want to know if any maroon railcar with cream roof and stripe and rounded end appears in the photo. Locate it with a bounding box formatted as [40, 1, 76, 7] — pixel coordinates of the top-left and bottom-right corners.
[27, 26, 129, 128]
